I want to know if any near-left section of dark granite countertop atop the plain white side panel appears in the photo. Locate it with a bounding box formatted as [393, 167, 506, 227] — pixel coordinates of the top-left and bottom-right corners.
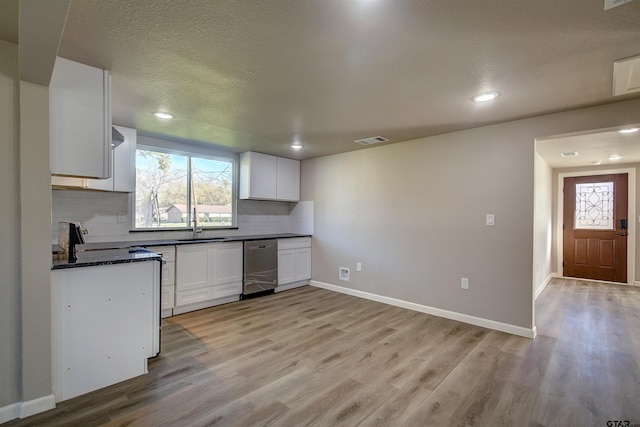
[51, 247, 162, 270]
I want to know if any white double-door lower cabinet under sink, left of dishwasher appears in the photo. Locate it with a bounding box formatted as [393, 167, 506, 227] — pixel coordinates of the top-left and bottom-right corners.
[173, 242, 242, 314]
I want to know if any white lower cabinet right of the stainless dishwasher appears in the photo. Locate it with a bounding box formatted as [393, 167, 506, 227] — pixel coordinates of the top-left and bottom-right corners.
[276, 237, 311, 292]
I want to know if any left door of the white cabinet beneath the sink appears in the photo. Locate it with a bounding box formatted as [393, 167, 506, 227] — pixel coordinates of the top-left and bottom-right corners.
[176, 243, 213, 291]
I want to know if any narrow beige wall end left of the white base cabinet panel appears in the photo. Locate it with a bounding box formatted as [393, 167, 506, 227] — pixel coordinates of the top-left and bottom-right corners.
[19, 81, 55, 408]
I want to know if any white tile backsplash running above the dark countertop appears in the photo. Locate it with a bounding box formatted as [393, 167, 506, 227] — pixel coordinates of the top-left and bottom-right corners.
[51, 190, 313, 243]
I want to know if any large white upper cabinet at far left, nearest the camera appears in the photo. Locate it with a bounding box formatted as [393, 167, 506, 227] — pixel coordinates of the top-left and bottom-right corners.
[49, 57, 111, 178]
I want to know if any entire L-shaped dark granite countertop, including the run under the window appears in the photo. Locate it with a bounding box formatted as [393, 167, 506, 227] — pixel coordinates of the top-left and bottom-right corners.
[51, 233, 311, 270]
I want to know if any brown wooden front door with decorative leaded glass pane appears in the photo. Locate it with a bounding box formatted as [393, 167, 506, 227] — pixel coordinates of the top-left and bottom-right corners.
[562, 173, 628, 283]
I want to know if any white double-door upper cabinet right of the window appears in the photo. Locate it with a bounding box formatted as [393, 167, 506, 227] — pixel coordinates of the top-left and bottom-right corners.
[240, 151, 300, 202]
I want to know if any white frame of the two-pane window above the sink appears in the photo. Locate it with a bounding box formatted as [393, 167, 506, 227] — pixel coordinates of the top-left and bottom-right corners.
[131, 144, 240, 232]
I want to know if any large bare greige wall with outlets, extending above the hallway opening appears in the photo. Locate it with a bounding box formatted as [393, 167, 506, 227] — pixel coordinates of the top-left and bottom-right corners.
[302, 101, 640, 331]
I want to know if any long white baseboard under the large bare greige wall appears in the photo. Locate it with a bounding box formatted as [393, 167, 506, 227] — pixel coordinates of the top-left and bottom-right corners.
[311, 280, 536, 338]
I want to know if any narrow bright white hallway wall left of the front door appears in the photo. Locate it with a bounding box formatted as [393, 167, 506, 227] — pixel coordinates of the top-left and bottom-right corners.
[533, 153, 553, 296]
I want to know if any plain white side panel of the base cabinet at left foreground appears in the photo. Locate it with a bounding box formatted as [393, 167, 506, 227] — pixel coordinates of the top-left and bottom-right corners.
[51, 261, 160, 401]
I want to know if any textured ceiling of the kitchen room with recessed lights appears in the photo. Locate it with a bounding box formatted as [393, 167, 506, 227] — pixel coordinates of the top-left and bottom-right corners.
[53, 0, 640, 158]
